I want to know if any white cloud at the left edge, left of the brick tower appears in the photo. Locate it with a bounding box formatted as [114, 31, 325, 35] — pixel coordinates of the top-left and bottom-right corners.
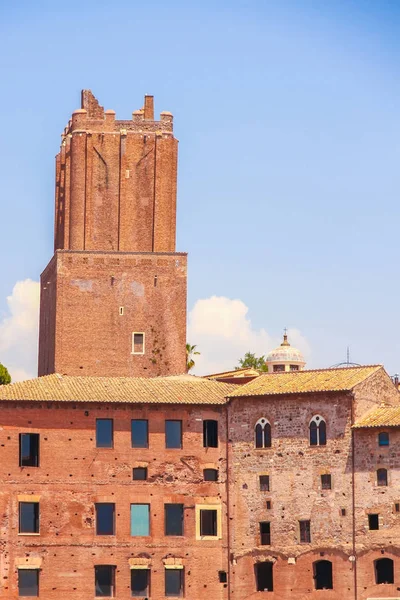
[0, 279, 40, 381]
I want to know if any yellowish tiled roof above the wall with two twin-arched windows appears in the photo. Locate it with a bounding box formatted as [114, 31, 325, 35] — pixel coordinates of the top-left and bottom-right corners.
[229, 365, 383, 398]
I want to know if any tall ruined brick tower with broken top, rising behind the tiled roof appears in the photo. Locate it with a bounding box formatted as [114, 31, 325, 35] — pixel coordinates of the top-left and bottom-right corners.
[39, 90, 187, 377]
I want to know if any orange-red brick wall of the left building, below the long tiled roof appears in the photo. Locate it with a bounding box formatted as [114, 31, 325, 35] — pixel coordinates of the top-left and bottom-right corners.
[0, 403, 228, 600]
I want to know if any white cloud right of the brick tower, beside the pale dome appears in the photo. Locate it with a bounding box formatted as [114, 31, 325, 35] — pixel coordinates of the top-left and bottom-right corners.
[188, 296, 310, 375]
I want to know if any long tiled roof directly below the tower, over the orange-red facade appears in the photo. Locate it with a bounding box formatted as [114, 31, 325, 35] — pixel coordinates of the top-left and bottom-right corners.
[0, 373, 236, 404]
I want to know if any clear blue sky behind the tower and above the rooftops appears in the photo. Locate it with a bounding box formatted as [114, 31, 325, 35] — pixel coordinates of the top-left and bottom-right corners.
[0, 0, 400, 373]
